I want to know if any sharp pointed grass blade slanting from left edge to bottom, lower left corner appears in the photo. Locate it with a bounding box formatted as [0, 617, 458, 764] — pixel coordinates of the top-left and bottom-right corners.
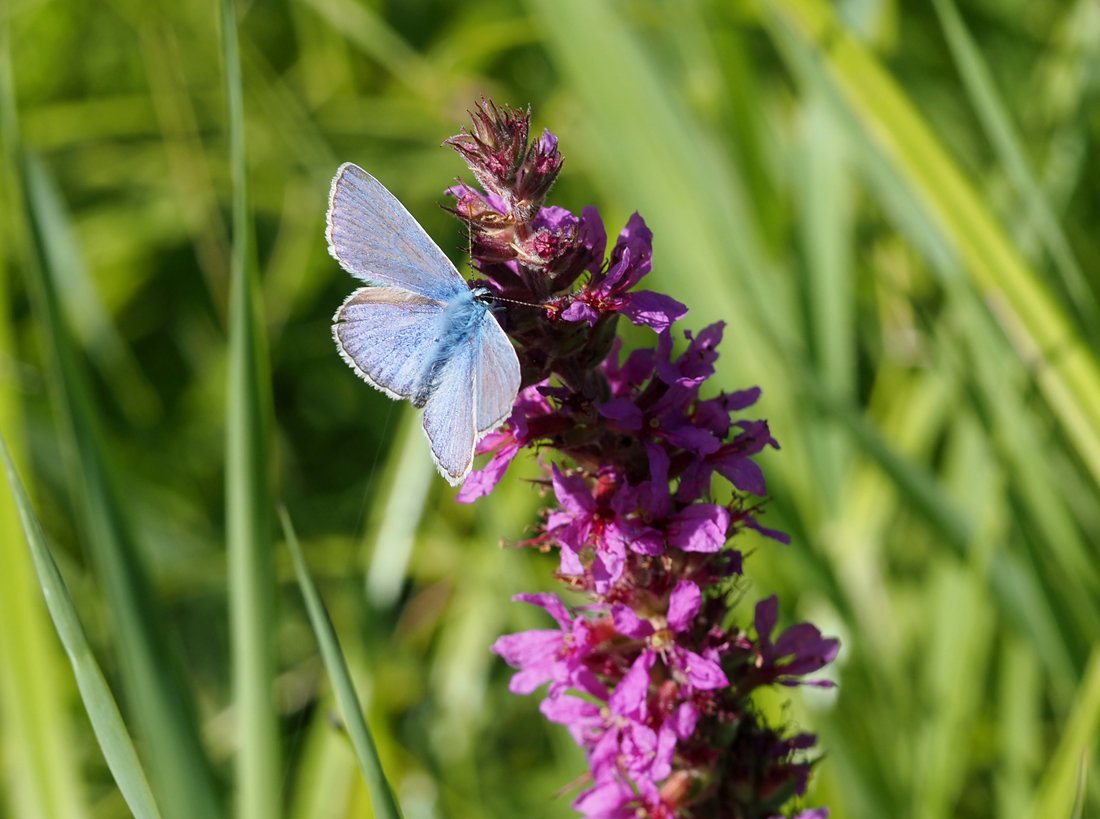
[0, 441, 161, 819]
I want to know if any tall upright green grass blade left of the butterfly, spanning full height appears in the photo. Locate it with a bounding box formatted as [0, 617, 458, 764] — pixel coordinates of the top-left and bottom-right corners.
[221, 0, 283, 819]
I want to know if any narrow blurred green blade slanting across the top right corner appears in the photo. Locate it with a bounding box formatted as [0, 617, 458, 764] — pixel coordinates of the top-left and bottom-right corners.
[932, 0, 1097, 328]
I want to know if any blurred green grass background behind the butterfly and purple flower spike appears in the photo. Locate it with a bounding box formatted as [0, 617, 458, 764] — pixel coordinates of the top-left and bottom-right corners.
[0, 0, 1100, 819]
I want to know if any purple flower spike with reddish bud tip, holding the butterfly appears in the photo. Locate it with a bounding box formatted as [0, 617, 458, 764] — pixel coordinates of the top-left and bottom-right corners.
[448, 100, 838, 819]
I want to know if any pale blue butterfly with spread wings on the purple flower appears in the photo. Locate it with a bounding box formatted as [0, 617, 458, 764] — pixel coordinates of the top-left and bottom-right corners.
[326, 163, 519, 486]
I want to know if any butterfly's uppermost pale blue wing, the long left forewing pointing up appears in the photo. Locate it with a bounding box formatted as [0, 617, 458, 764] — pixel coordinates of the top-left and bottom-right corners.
[326, 163, 466, 301]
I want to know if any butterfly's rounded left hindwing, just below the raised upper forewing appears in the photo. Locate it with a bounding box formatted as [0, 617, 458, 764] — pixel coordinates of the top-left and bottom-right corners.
[332, 287, 446, 398]
